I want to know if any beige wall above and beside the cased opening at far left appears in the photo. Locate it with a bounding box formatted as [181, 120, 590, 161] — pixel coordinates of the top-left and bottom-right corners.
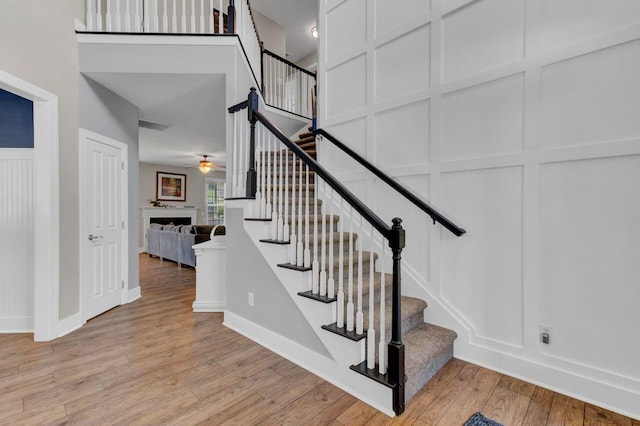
[0, 1, 80, 319]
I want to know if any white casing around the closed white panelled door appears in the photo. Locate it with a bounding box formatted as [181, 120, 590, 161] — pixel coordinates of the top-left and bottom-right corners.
[78, 128, 128, 321]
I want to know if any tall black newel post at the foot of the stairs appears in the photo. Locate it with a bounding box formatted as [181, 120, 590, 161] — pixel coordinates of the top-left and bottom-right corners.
[388, 217, 407, 415]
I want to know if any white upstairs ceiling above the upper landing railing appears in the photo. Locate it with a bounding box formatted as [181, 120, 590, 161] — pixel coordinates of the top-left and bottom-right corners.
[251, 0, 318, 62]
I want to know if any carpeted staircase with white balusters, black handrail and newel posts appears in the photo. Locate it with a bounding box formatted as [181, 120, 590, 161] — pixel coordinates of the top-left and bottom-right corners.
[230, 90, 464, 414]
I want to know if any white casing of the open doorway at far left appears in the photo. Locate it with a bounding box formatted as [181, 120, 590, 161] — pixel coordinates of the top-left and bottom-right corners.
[0, 71, 60, 341]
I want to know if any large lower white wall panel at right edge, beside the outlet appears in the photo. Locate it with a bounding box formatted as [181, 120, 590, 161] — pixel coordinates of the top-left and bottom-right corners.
[540, 155, 640, 383]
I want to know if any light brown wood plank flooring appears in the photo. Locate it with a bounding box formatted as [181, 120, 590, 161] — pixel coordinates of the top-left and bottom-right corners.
[0, 255, 640, 426]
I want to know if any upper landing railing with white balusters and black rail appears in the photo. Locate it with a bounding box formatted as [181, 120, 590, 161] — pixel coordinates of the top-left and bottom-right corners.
[85, 0, 316, 118]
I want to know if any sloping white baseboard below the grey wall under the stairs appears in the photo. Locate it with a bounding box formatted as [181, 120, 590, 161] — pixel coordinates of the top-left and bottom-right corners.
[223, 311, 395, 417]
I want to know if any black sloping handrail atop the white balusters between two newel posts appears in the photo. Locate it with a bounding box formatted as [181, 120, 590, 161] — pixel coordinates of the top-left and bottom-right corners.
[253, 111, 392, 240]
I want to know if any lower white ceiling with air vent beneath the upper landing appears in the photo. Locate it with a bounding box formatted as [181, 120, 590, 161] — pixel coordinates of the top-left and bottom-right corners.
[86, 72, 226, 166]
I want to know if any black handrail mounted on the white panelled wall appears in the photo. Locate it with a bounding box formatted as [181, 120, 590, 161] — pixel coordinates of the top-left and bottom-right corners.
[313, 129, 467, 237]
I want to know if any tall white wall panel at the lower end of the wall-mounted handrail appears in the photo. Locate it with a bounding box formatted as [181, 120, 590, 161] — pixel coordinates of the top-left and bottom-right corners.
[440, 167, 523, 347]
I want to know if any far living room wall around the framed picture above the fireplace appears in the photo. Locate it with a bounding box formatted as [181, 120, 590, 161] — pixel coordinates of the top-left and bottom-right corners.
[136, 163, 225, 251]
